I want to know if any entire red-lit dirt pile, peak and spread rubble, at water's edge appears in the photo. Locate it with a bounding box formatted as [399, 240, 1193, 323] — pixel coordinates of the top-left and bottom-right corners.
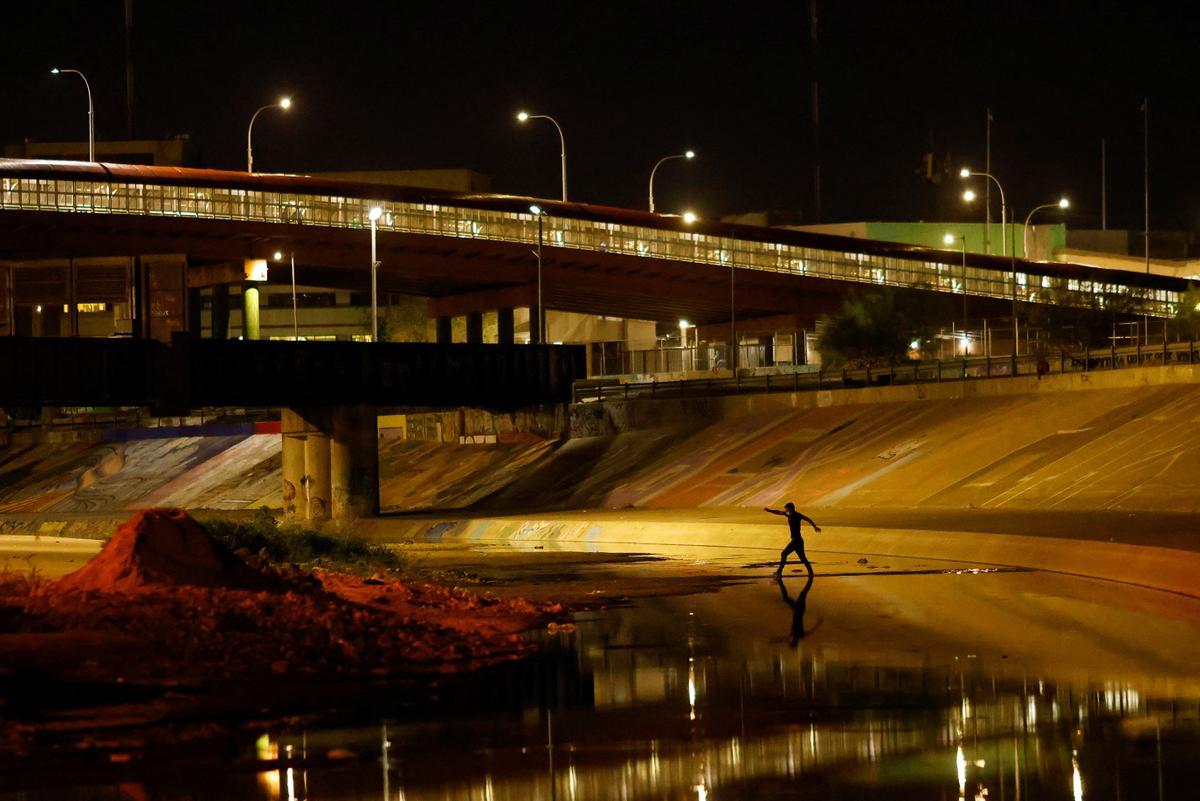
[0, 510, 562, 688]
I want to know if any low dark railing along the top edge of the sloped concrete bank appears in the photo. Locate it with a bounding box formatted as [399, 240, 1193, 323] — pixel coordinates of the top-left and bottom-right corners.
[574, 342, 1200, 403]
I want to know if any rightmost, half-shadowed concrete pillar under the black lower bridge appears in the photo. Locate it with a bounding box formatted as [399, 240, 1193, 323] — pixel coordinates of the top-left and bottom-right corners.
[329, 404, 379, 520]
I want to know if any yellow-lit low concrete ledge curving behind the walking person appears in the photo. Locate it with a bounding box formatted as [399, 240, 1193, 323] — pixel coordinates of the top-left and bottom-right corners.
[360, 516, 1200, 597]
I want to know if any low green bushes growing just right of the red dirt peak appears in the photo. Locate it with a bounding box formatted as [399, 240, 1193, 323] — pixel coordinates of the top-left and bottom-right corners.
[199, 510, 404, 573]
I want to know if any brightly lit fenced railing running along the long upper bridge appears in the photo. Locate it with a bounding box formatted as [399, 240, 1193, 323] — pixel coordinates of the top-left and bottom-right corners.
[0, 176, 1182, 317]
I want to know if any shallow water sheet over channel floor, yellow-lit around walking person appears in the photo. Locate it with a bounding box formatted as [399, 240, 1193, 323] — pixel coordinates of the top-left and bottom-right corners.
[0, 544, 1200, 801]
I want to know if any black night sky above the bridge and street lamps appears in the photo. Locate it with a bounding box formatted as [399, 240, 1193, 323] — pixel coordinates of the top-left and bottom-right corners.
[0, 0, 1200, 228]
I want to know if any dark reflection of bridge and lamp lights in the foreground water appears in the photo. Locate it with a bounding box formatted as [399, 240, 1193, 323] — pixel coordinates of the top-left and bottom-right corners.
[0, 578, 1200, 801]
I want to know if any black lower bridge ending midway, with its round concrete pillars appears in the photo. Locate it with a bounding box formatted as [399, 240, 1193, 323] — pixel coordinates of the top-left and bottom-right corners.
[0, 335, 584, 522]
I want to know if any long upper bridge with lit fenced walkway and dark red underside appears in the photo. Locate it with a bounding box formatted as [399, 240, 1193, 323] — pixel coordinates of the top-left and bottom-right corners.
[0, 159, 1187, 342]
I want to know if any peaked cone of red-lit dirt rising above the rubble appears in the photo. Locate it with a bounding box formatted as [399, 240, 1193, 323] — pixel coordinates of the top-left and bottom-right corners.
[54, 508, 268, 592]
